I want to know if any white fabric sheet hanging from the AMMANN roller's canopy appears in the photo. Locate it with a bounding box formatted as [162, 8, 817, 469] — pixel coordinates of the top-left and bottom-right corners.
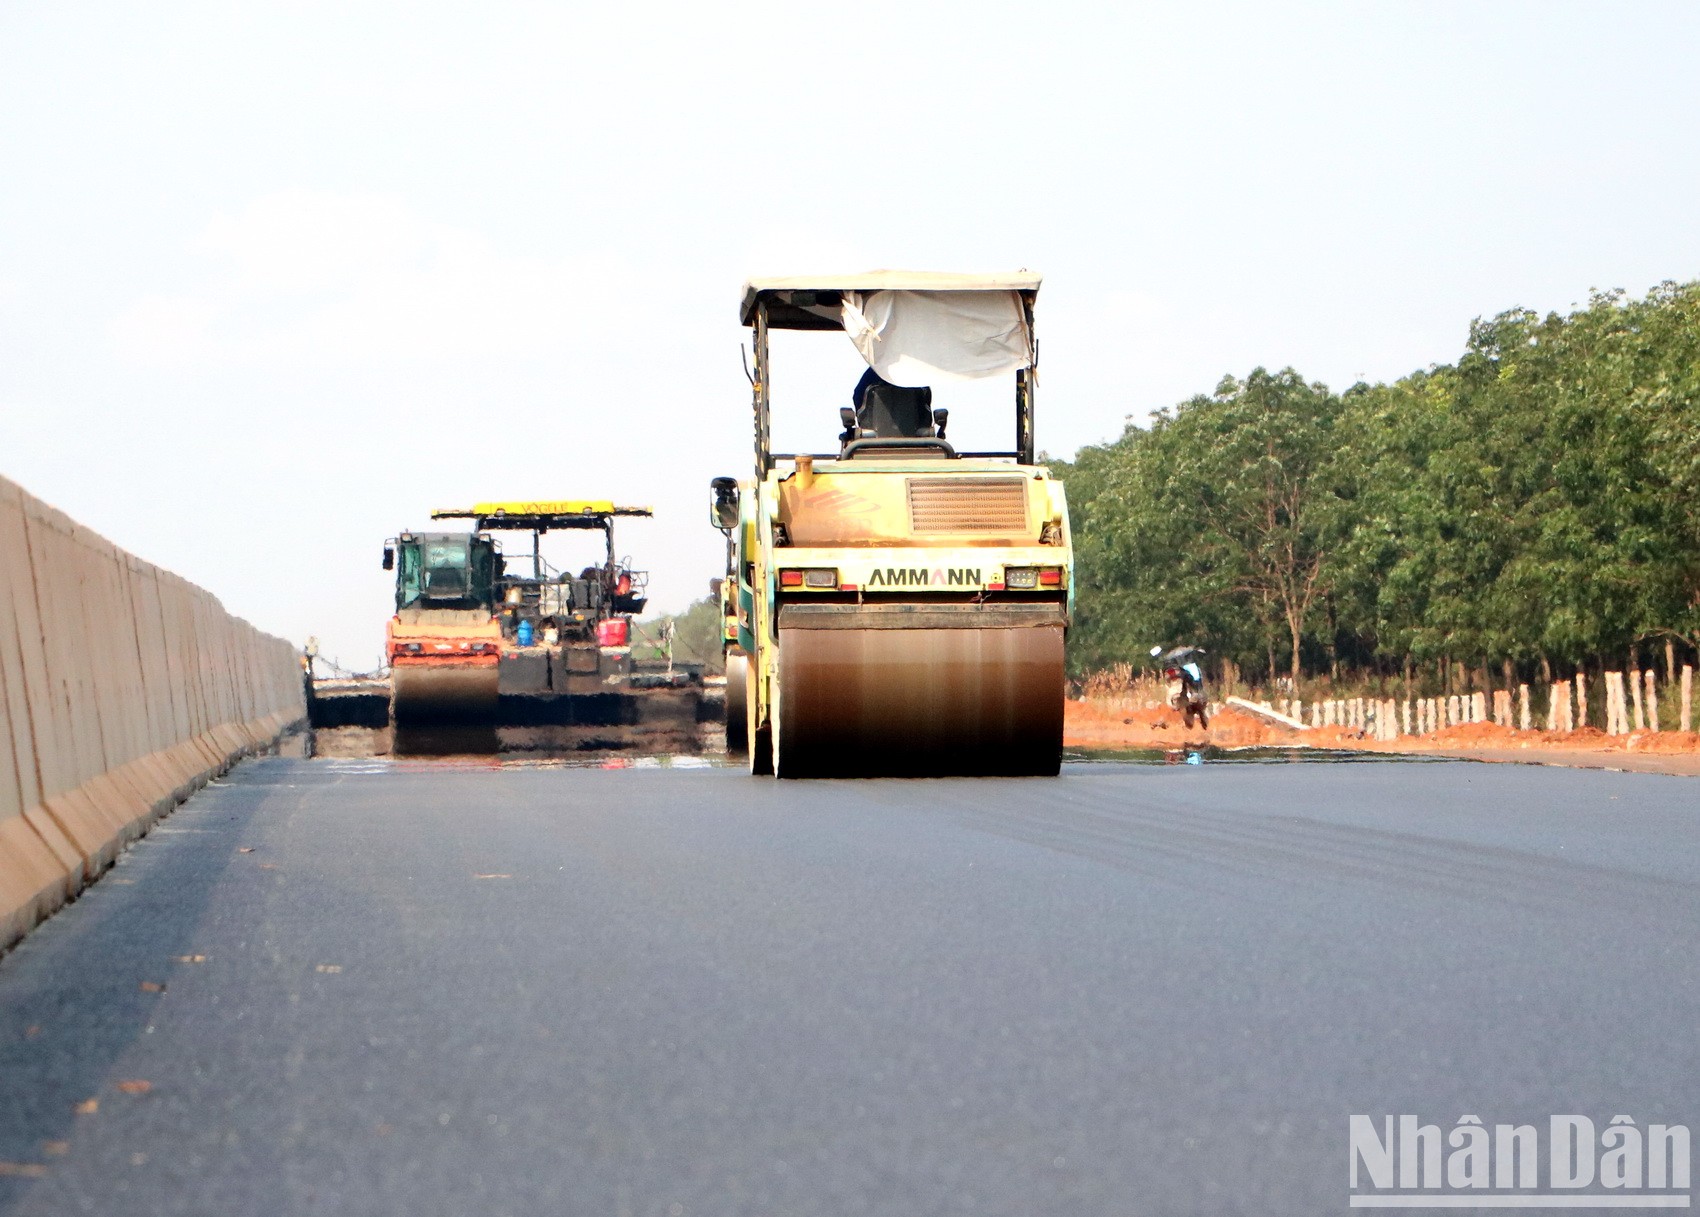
[843, 291, 1034, 388]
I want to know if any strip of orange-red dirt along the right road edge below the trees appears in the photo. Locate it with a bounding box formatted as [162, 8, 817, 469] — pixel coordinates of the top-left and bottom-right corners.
[1063, 700, 1700, 775]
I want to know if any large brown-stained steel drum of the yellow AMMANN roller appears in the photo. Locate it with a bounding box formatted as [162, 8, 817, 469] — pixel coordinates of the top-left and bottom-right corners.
[772, 624, 1063, 777]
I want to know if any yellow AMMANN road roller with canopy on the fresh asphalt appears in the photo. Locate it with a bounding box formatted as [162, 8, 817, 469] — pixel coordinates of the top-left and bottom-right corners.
[711, 272, 1074, 778]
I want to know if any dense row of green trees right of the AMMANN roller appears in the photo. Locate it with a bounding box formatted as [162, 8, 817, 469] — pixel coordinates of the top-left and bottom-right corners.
[1051, 284, 1700, 687]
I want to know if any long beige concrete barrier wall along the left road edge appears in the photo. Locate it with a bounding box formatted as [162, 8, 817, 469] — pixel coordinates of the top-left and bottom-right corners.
[0, 478, 306, 950]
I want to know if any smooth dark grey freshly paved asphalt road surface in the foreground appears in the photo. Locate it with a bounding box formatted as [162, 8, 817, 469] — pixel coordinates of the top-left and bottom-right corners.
[0, 760, 1700, 1217]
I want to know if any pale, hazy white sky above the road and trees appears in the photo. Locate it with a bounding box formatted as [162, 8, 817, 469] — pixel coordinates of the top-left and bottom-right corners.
[0, 0, 1700, 668]
